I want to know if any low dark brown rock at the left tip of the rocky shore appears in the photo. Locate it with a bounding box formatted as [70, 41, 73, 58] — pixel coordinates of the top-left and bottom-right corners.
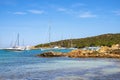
[37, 51, 65, 57]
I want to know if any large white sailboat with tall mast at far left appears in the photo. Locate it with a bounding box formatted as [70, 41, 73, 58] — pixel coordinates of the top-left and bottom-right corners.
[4, 34, 25, 51]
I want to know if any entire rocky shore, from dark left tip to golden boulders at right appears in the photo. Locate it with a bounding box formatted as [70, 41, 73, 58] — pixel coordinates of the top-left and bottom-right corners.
[37, 44, 120, 58]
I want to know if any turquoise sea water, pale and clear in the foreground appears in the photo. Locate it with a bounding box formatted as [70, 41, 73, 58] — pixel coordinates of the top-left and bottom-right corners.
[0, 49, 120, 80]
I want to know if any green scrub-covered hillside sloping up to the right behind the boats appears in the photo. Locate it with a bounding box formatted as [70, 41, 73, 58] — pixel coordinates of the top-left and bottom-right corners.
[35, 33, 120, 48]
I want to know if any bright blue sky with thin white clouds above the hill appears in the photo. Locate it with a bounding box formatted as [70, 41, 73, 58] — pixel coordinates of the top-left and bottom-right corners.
[0, 0, 120, 47]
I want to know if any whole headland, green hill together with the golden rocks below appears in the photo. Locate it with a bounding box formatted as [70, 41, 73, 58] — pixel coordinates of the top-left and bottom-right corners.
[34, 33, 120, 58]
